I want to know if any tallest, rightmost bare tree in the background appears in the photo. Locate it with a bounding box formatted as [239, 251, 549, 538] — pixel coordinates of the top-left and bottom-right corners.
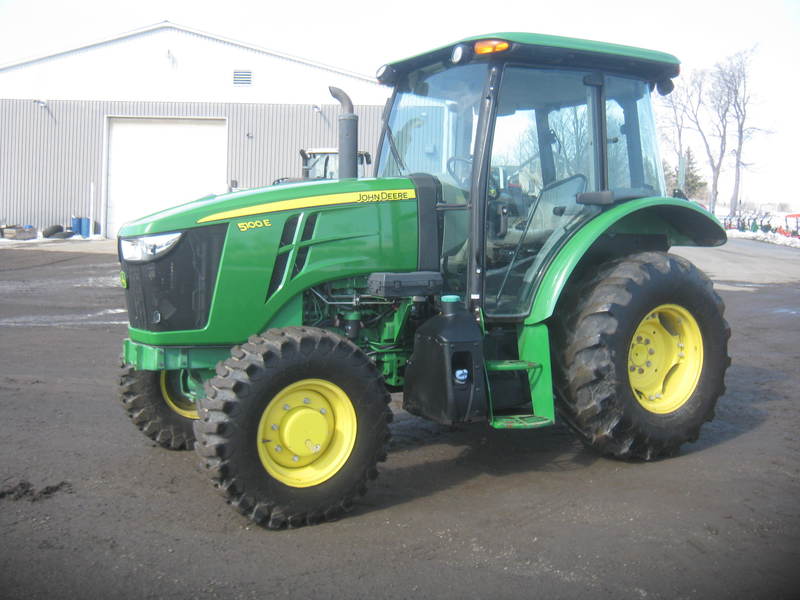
[714, 48, 758, 215]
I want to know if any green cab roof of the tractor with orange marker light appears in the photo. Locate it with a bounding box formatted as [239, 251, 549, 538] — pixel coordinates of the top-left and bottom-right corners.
[390, 32, 680, 81]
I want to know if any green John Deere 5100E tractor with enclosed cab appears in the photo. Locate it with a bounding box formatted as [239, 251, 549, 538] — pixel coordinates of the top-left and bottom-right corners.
[119, 33, 730, 528]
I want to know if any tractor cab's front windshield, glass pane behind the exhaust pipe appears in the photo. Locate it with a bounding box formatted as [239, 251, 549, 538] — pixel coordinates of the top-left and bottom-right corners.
[377, 63, 488, 191]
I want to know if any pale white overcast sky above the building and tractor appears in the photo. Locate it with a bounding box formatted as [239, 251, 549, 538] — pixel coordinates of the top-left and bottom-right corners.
[0, 0, 800, 209]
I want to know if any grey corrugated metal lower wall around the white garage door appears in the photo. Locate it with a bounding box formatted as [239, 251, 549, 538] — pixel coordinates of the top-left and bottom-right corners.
[0, 100, 383, 229]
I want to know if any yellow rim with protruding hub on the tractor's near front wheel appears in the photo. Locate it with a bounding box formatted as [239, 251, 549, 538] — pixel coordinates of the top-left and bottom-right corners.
[257, 379, 357, 488]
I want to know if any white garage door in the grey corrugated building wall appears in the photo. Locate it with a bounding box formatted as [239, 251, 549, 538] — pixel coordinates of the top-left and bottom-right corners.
[106, 118, 228, 238]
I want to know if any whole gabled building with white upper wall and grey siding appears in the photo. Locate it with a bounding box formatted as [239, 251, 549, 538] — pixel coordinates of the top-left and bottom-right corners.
[0, 22, 388, 236]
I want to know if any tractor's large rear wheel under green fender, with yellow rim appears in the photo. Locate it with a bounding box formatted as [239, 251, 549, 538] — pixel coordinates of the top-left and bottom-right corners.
[555, 252, 730, 460]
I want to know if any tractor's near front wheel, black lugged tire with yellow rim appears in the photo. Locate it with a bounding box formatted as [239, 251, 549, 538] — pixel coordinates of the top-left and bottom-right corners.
[195, 327, 392, 529]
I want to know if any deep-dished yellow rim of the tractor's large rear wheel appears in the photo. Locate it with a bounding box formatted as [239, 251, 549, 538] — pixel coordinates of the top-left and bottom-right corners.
[628, 304, 703, 415]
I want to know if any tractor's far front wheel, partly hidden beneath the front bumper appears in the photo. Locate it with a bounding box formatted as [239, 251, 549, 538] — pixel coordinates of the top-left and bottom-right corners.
[120, 366, 197, 450]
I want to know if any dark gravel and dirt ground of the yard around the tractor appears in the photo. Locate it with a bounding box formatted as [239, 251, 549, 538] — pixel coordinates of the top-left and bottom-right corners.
[0, 240, 800, 600]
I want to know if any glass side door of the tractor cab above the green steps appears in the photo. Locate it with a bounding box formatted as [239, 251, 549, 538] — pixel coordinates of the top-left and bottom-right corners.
[483, 66, 602, 318]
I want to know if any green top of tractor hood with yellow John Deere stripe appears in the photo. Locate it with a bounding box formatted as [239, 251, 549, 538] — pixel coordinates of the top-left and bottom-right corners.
[119, 177, 416, 238]
